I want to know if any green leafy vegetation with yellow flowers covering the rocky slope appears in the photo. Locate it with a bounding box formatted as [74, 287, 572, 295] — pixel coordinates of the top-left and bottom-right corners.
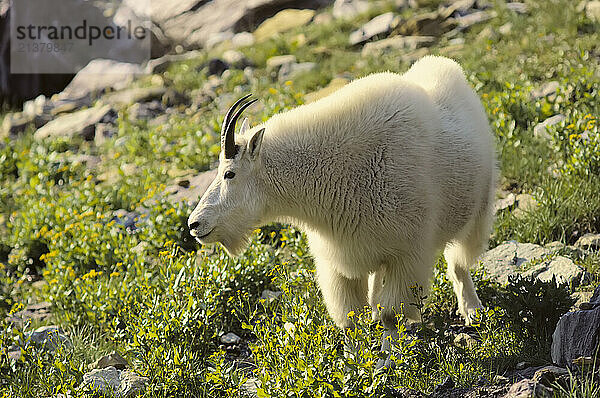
[0, 0, 600, 398]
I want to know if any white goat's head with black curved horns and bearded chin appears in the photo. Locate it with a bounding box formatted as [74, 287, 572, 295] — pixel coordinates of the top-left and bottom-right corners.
[188, 94, 266, 255]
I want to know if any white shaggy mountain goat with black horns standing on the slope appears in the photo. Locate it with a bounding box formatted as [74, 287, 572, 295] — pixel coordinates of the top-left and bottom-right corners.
[188, 56, 497, 354]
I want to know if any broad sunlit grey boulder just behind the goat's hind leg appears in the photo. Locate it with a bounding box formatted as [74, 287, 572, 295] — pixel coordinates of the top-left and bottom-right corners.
[480, 241, 589, 286]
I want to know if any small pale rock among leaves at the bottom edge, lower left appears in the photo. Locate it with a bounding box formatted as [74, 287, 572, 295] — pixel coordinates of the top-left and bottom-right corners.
[79, 366, 148, 398]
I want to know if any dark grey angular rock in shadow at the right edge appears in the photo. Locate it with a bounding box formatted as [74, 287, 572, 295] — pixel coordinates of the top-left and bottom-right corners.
[551, 306, 600, 366]
